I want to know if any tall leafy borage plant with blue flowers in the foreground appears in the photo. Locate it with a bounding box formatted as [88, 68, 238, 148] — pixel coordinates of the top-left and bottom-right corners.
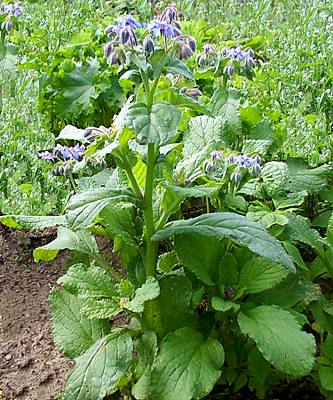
[3, 7, 315, 400]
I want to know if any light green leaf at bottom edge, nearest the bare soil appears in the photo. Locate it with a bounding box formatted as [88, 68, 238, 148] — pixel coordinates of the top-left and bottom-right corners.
[62, 333, 133, 400]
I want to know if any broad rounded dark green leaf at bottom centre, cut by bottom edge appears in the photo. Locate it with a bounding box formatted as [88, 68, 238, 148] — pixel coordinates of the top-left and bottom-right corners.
[151, 327, 224, 400]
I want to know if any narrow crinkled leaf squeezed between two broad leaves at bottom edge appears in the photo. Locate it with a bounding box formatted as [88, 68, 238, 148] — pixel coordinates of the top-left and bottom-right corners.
[132, 332, 157, 400]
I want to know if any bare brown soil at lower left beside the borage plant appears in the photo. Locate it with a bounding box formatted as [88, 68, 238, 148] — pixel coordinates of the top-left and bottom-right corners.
[0, 225, 72, 400]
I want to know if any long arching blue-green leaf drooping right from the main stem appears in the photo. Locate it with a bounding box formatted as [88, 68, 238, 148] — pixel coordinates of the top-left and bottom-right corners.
[153, 212, 295, 271]
